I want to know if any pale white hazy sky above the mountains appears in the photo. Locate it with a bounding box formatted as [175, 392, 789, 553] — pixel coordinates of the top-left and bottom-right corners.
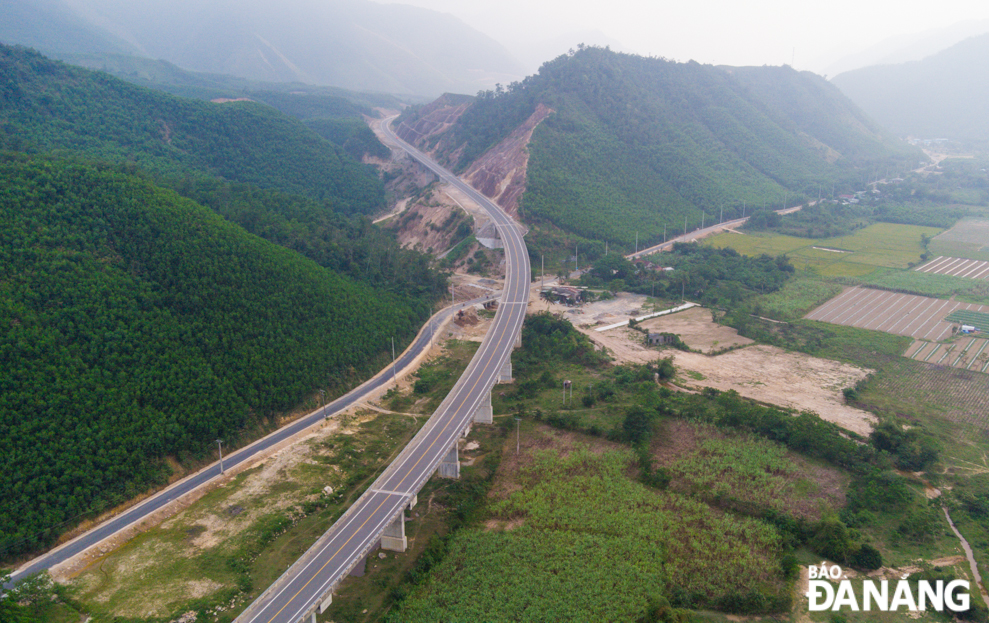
[378, 0, 989, 73]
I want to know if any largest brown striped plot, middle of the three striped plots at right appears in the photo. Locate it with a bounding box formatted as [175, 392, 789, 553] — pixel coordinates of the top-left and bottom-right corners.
[805, 287, 989, 342]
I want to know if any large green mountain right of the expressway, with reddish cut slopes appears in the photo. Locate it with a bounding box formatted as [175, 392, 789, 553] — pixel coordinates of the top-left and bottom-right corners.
[396, 47, 919, 247]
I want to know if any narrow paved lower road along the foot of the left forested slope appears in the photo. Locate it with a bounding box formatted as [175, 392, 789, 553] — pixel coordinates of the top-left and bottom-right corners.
[5, 297, 491, 588]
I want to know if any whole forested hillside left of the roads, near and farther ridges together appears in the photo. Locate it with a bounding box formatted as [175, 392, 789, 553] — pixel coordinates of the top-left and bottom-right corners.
[0, 46, 445, 559]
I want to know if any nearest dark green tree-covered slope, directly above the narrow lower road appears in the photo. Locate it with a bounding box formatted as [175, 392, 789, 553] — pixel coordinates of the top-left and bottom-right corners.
[0, 155, 426, 557]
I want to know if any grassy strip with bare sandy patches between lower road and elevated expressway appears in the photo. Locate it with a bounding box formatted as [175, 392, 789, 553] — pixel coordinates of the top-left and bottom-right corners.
[70, 415, 421, 623]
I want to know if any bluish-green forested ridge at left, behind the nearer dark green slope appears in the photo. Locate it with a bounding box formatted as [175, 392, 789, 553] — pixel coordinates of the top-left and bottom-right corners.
[0, 46, 384, 214]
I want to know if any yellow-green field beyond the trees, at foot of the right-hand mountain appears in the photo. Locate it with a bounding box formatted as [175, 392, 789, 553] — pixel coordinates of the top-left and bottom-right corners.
[703, 223, 941, 277]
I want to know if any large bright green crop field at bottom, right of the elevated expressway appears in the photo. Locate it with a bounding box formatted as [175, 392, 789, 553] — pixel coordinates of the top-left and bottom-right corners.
[388, 446, 787, 623]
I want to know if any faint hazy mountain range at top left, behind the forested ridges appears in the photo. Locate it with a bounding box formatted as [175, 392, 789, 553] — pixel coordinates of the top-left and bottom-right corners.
[0, 0, 524, 96]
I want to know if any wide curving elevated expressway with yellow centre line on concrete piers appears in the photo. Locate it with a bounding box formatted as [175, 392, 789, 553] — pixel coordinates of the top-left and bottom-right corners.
[236, 118, 531, 623]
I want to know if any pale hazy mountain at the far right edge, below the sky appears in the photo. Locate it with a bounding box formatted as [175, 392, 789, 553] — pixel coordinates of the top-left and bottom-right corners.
[832, 34, 989, 141]
